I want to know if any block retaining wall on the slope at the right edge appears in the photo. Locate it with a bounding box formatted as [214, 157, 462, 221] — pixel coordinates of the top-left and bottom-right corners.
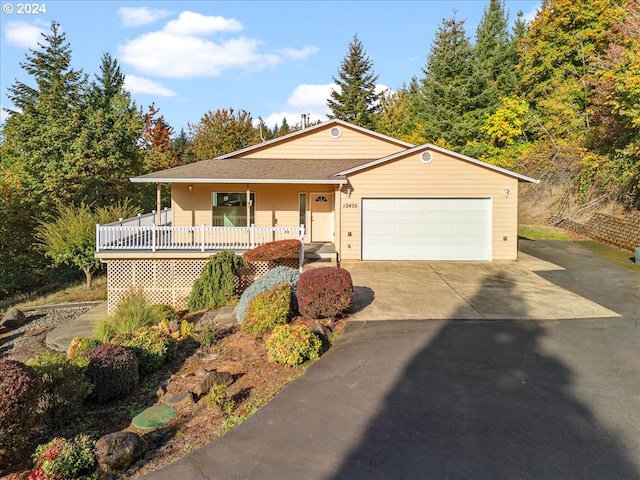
[553, 210, 640, 251]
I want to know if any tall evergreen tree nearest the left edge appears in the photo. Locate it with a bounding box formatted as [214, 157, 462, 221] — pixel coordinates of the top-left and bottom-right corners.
[1, 22, 86, 206]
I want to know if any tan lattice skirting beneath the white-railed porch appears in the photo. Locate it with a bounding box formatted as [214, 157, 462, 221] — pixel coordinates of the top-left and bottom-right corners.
[106, 258, 299, 313]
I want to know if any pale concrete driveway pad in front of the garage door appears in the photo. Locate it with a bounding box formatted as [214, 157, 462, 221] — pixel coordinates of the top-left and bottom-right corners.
[341, 253, 620, 321]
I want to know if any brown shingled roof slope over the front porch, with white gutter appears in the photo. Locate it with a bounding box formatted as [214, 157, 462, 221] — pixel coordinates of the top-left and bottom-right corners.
[131, 157, 371, 184]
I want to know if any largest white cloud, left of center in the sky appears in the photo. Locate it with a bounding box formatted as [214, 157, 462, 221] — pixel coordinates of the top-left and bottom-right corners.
[118, 11, 318, 78]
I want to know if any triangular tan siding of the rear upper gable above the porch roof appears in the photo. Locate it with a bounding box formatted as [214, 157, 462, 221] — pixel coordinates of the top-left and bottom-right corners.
[244, 127, 406, 159]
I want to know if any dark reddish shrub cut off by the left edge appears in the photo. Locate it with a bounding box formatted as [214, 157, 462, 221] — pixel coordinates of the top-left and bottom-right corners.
[0, 358, 42, 464]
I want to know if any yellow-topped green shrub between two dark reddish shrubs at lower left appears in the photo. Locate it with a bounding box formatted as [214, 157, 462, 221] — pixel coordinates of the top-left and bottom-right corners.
[27, 350, 91, 427]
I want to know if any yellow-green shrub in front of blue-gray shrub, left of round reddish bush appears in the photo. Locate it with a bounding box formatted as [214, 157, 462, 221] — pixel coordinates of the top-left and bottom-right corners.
[241, 283, 291, 335]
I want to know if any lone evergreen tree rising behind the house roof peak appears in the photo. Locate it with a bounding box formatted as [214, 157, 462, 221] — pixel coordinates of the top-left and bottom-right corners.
[327, 35, 382, 128]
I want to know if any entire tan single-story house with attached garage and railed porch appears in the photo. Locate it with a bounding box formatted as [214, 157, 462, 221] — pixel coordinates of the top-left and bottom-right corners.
[97, 120, 538, 312]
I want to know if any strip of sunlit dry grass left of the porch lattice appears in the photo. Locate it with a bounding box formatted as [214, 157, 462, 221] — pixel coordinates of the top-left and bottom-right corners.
[0, 275, 107, 313]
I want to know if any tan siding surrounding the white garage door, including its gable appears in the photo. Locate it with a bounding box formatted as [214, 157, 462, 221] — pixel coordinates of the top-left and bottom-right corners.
[340, 152, 518, 260]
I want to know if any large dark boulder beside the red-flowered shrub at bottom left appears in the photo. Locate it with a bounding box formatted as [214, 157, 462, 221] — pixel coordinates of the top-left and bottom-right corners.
[96, 432, 147, 475]
